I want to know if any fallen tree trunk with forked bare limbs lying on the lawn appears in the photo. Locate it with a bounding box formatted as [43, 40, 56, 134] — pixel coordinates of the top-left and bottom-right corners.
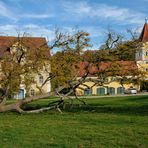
[0, 73, 88, 114]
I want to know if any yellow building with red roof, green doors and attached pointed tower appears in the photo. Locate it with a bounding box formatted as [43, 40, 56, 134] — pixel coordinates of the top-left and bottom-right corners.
[76, 21, 148, 96]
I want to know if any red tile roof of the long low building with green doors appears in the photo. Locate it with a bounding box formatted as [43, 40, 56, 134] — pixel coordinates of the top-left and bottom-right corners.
[78, 61, 138, 76]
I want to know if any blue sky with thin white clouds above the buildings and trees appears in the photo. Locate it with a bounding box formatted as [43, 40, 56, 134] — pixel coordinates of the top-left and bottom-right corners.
[0, 0, 148, 48]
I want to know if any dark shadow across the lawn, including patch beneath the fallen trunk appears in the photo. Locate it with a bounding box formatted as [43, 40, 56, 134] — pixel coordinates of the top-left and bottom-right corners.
[24, 104, 148, 116]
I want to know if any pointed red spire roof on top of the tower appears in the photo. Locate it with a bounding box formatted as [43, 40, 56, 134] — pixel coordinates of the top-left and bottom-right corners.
[139, 23, 148, 42]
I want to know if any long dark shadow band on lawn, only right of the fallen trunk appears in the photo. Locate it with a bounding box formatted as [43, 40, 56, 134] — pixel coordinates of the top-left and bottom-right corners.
[64, 104, 148, 116]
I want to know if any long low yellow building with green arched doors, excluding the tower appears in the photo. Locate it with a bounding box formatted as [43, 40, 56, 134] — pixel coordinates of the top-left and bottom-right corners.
[76, 61, 140, 96]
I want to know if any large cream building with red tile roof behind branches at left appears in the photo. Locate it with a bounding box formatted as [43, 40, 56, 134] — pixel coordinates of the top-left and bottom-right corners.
[0, 36, 51, 99]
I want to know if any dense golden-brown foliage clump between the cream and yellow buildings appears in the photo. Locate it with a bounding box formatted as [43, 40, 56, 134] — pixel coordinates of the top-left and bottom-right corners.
[50, 50, 80, 89]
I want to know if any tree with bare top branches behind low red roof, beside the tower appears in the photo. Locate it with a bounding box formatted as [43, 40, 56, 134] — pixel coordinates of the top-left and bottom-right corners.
[97, 29, 141, 61]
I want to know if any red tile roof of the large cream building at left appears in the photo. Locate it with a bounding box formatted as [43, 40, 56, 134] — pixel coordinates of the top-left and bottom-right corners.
[0, 36, 50, 56]
